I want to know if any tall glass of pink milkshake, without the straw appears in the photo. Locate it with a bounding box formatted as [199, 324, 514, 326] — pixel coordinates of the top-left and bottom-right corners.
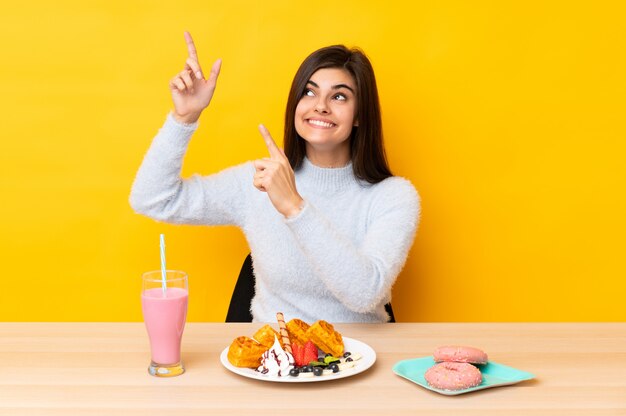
[141, 270, 188, 377]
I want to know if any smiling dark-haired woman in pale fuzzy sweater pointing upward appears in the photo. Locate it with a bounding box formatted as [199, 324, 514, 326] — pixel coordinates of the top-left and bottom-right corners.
[130, 33, 420, 322]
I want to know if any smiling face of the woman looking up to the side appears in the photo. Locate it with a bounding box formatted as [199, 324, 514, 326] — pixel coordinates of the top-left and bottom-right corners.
[295, 68, 357, 153]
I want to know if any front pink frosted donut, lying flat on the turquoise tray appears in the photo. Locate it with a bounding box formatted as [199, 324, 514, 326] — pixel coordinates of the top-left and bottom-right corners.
[424, 362, 483, 390]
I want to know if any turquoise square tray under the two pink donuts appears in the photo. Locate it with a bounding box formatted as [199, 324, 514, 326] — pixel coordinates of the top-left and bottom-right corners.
[393, 356, 535, 396]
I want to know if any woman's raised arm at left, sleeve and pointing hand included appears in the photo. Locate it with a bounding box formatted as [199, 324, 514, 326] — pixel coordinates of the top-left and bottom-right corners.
[130, 32, 253, 224]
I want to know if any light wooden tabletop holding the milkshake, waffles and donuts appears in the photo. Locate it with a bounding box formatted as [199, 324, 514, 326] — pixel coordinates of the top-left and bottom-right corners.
[0, 323, 626, 416]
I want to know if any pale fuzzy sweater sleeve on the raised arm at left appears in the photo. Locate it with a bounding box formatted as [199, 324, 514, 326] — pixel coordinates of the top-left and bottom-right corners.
[129, 114, 253, 225]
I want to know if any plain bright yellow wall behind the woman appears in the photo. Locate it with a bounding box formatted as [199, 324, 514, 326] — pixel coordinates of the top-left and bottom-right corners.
[0, 0, 626, 321]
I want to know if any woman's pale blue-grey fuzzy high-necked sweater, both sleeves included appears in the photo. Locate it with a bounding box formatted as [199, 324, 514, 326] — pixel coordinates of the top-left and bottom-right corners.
[130, 114, 420, 323]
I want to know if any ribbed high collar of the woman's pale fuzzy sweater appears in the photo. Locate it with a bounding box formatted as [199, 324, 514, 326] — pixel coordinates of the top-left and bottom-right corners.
[296, 157, 359, 193]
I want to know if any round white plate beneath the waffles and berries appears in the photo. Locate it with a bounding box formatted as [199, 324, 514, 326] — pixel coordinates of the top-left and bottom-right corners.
[220, 337, 376, 383]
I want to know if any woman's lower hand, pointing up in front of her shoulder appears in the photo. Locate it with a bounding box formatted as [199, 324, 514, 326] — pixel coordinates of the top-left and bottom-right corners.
[254, 124, 304, 218]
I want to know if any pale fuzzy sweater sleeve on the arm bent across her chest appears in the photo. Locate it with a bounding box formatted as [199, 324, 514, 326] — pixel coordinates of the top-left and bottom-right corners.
[286, 177, 420, 313]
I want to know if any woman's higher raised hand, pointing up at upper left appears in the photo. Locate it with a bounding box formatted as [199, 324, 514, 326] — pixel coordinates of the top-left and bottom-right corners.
[169, 32, 222, 123]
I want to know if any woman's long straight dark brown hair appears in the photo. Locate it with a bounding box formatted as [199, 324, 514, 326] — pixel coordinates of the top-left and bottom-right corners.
[284, 45, 393, 183]
